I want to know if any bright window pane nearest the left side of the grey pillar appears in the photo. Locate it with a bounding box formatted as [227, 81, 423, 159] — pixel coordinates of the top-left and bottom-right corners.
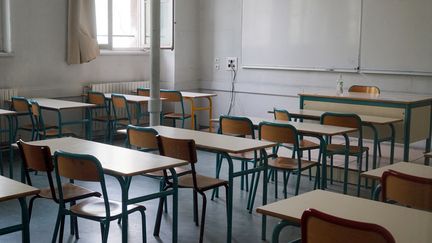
[113, 0, 144, 48]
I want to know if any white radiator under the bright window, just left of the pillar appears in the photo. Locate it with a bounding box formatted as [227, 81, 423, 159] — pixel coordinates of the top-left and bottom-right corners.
[84, 81, 150, 135]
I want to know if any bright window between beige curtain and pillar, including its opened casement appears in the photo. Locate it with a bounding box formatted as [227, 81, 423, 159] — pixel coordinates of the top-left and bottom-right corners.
[96, 0, 174, 50]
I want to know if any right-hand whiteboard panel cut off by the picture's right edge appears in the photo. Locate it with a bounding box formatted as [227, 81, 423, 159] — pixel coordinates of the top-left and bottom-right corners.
[360, 0, 432, 73]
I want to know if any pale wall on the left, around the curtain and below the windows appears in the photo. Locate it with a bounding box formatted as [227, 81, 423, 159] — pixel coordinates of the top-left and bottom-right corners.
[0, 0, 202, 97]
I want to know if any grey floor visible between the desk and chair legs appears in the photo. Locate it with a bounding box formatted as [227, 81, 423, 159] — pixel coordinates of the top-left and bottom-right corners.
[0, 137, 421, 243]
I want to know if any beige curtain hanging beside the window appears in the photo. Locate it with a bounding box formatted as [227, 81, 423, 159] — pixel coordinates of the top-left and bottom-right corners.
[67, 0, 100, 64]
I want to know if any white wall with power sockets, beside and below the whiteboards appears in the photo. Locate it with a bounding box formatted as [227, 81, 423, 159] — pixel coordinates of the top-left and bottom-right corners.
[199, 0, 432, 116]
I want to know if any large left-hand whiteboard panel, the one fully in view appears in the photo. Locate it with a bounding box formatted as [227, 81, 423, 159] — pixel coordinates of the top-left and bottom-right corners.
[242, 0, 361, 70]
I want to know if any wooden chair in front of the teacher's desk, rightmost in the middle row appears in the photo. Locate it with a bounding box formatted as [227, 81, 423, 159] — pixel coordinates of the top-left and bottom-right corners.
[320, 112, 369, 196]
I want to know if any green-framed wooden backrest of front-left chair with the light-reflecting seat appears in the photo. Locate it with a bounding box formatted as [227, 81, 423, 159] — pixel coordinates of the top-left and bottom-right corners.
[54, 151, 110, 217]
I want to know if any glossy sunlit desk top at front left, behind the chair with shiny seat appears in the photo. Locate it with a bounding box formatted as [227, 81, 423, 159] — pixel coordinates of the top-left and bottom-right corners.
[30, 137, 188, 176]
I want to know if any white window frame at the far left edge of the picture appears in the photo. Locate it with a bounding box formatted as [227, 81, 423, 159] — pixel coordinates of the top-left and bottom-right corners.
[0, 0, 12, 56]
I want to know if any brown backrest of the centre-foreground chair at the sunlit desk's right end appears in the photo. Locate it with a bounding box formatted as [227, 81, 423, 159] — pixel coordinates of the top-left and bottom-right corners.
[157, 135, 197, 164]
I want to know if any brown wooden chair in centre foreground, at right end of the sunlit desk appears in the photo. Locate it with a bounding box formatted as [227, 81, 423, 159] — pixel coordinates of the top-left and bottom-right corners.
[154, 136, 228, 242]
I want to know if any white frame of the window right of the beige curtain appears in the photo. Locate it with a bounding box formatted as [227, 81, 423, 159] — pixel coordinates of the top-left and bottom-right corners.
[98, 0, 175, 53]
